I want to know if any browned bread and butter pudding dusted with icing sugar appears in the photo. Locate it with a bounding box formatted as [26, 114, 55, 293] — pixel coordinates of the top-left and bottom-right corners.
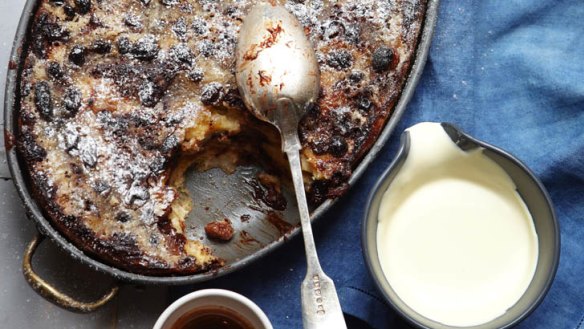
[17, 0, 426, 275]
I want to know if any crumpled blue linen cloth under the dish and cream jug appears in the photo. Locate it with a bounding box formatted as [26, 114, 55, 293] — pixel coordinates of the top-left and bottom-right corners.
[173, 0, 584, 329]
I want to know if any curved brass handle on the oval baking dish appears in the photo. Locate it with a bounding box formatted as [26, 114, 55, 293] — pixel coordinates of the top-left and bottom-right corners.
[22, 233, 119, 313]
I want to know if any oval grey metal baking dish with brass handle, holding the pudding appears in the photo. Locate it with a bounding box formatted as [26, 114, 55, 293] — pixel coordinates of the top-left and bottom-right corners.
[4, 0, 438, 312]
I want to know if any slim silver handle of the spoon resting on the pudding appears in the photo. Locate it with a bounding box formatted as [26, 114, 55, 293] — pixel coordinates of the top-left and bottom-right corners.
[284, 144, 347, 329]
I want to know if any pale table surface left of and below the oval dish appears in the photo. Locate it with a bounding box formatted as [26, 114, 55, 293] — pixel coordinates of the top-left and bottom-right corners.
[0, 0, 169, 329]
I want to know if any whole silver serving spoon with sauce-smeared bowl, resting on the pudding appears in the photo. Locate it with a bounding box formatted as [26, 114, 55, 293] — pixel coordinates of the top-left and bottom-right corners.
[236, 2, 347, 329]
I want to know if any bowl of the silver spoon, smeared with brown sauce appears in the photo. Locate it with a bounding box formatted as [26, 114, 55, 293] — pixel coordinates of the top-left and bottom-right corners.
[236, 3, 320, 126]
